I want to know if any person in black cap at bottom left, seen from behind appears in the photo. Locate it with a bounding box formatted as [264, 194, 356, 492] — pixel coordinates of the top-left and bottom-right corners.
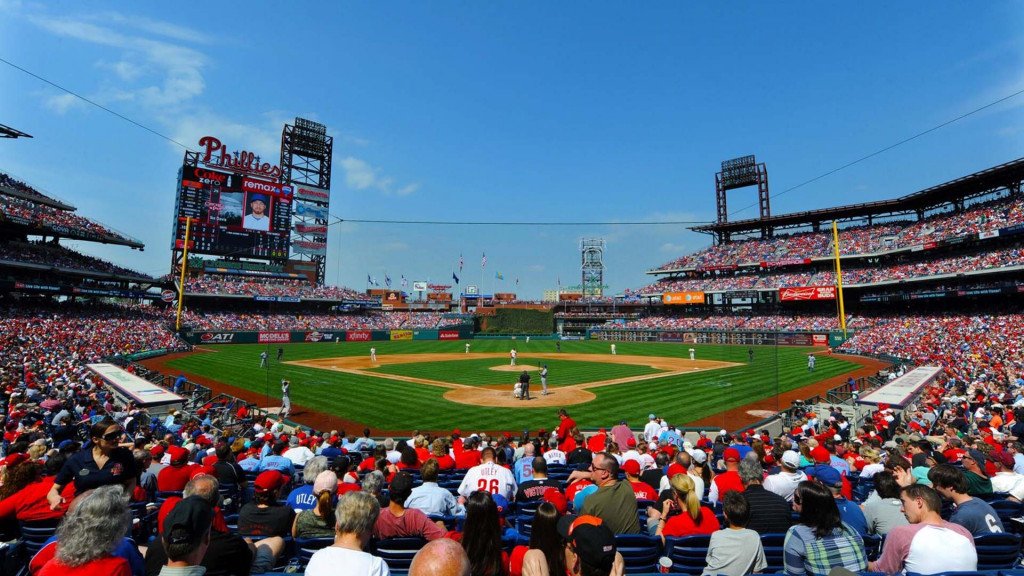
[153, 496, 213, 576]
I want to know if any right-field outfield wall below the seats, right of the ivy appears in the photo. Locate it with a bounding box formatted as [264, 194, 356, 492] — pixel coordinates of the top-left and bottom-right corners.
[588, 329, 844, 347]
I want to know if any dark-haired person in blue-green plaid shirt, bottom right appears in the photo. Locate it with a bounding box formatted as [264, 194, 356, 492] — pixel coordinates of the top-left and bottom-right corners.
[783, 481, 867, 576]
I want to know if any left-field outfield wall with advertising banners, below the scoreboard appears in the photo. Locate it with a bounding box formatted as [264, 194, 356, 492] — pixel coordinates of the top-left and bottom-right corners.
[184, 326, 473, 344]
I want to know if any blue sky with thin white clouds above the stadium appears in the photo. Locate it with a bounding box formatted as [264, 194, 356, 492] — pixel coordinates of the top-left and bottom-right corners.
[0, 0, 1024, 297]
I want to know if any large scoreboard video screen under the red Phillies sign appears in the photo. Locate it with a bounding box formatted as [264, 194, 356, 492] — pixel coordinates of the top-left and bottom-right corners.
[174, 166, 292, 258]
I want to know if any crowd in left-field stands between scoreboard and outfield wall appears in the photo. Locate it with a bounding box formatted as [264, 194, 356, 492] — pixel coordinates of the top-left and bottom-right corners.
[184, 311, 458, 330]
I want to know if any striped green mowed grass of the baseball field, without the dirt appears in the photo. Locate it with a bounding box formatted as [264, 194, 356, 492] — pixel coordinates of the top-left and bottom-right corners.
[170, 340, 857, 431]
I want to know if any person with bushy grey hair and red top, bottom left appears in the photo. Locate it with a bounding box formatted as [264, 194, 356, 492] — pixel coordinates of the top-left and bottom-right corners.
[38, 483, 138, 576]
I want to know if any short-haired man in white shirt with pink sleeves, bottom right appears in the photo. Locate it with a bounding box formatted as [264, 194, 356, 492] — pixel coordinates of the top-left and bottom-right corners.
[867, 484, 978, 574]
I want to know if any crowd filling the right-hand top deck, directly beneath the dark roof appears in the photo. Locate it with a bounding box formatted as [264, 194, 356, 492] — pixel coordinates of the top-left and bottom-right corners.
[656, 198, 1024, 270]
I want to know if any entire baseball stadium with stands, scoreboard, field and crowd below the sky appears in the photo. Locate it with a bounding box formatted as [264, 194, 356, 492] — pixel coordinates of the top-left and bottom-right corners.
[0, 4, 1024, 576]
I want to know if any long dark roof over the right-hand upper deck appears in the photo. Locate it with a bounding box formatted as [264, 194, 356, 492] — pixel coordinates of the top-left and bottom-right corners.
[690, 158, 1024, 233]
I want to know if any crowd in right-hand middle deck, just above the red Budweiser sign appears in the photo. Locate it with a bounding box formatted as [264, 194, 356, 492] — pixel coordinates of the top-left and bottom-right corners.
[640, 245, 1024, 294]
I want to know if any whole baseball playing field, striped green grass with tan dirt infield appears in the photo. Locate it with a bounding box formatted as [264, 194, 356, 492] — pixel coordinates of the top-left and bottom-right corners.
[161, 339, 862, 431]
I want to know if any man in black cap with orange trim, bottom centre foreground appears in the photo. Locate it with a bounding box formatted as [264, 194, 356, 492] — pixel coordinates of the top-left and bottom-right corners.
[557, 516, 626, 576]
